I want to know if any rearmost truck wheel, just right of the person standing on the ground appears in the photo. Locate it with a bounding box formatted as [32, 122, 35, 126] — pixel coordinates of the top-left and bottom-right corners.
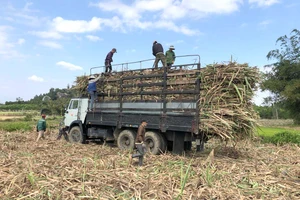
[145, 131, 166, 155]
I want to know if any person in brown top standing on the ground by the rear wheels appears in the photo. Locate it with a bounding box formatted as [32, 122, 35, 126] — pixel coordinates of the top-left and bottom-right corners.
[132, 120, 148, 166]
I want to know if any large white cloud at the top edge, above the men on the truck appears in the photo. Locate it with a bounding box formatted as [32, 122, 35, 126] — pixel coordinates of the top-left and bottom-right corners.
[90, 0, 243, 35]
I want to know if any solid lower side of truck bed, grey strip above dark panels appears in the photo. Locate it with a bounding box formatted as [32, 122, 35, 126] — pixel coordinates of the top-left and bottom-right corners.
[86, 102, 198, 132]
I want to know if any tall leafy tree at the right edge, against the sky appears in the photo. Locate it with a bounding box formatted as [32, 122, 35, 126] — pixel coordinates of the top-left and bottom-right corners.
[261, 29, 300, 124]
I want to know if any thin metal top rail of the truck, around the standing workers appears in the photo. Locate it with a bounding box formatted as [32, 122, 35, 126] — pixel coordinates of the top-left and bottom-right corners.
[90, 54, 201, 74]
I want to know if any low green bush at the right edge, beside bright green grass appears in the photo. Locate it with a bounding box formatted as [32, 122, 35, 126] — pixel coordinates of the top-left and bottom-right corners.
[263, 131, 300, 145]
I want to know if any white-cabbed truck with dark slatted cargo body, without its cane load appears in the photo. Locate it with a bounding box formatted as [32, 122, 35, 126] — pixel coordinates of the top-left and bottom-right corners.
[64, 55, 205, 154]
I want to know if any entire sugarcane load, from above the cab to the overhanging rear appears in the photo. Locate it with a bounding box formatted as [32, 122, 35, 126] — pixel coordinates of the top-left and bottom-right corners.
[74, 62, 259, 139]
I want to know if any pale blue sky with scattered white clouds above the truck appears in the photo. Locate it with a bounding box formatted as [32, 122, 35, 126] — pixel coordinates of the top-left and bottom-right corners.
[0, 0, 300, 105]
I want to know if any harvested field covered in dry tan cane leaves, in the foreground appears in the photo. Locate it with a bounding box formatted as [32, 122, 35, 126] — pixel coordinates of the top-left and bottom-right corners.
[0, 132, 300, 199]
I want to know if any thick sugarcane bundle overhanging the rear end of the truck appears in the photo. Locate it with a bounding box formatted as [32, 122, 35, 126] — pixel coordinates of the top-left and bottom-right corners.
[199, 63, 260, 139]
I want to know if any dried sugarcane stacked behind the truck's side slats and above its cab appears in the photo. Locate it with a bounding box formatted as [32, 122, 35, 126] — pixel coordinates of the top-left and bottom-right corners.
[73, 68, 199, 101]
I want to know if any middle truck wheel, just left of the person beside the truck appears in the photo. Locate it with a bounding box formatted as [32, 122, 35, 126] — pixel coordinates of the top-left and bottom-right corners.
[117, 130, 136, 150]
